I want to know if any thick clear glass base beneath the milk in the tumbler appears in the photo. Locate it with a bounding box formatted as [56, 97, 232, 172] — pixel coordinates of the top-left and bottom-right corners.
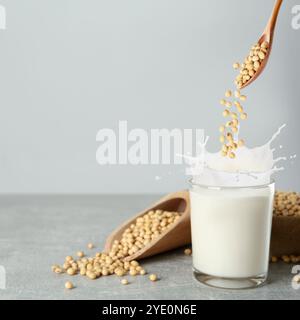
[194, 269, 268, 290]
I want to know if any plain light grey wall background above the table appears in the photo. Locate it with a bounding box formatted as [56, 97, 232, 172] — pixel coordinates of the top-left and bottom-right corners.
[0, 0, 300, 193]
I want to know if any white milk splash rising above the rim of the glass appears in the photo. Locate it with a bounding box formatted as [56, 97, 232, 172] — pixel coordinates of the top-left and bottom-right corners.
[184, 124, 287, 187]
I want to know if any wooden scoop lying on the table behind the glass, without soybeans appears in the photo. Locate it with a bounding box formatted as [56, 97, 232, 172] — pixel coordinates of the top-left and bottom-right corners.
[104, 191, 191, 261]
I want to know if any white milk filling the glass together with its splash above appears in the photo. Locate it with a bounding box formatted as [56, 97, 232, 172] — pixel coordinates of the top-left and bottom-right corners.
[186, 126, 285, 279]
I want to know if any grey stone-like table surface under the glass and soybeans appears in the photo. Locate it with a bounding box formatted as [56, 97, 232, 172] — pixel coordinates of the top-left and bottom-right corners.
[0, 195, 300, 300]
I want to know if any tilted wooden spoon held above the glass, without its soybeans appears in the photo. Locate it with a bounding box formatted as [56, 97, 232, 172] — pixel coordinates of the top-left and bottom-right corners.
[241, 0, 283, 89]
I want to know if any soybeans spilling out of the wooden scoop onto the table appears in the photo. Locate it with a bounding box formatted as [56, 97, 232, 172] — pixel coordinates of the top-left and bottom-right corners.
[52, 210, 191, 289]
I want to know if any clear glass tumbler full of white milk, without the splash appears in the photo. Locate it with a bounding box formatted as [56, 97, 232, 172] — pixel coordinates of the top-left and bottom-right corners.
[190, 182, 275, 289]
